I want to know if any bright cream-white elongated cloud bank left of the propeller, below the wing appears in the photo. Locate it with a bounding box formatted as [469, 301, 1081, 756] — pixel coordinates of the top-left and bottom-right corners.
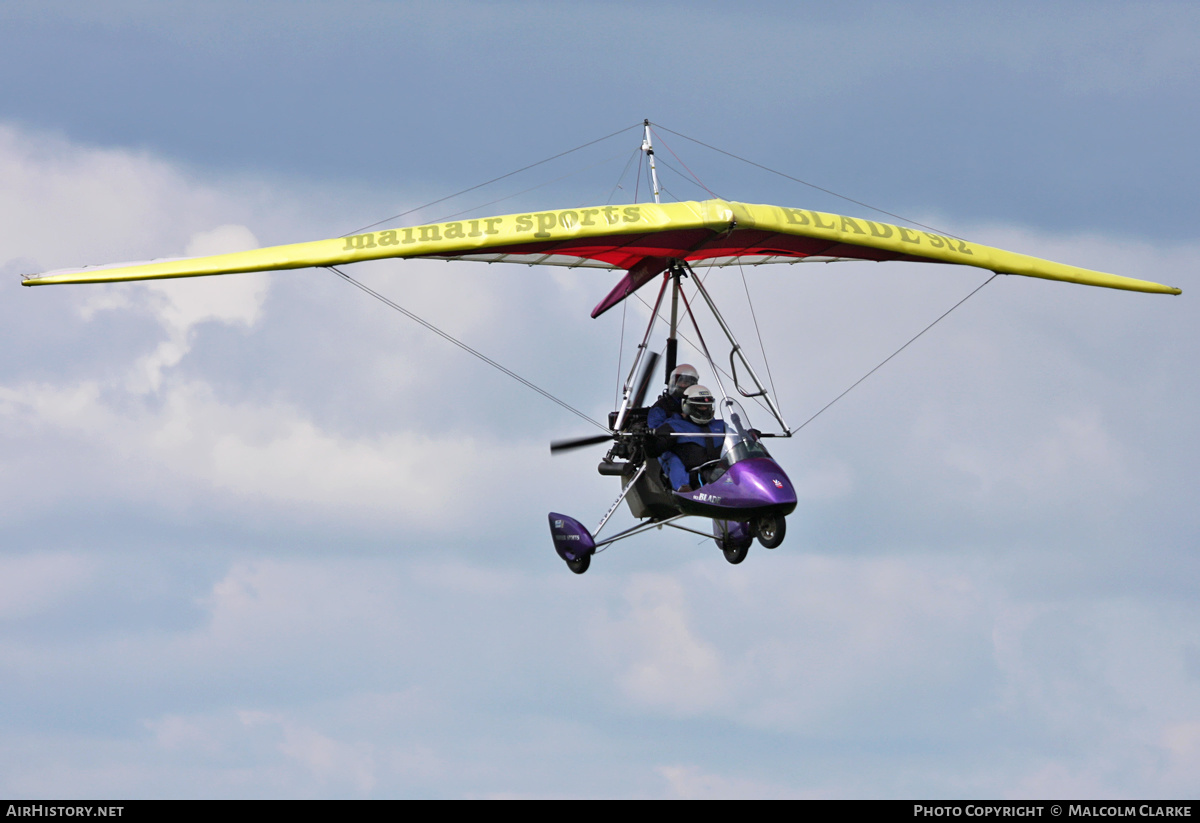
[0, 382, 549, 528]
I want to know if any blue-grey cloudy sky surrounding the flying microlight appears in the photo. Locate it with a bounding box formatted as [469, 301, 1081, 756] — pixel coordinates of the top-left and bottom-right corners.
[0, 0, 1200, 798]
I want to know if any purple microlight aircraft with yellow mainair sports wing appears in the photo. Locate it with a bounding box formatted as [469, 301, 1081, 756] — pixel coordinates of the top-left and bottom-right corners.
[23, 121, 1181, 573]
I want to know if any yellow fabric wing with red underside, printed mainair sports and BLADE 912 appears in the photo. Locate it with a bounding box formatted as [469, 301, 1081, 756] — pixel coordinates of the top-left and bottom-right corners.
[23, 200, 1181, 317]
